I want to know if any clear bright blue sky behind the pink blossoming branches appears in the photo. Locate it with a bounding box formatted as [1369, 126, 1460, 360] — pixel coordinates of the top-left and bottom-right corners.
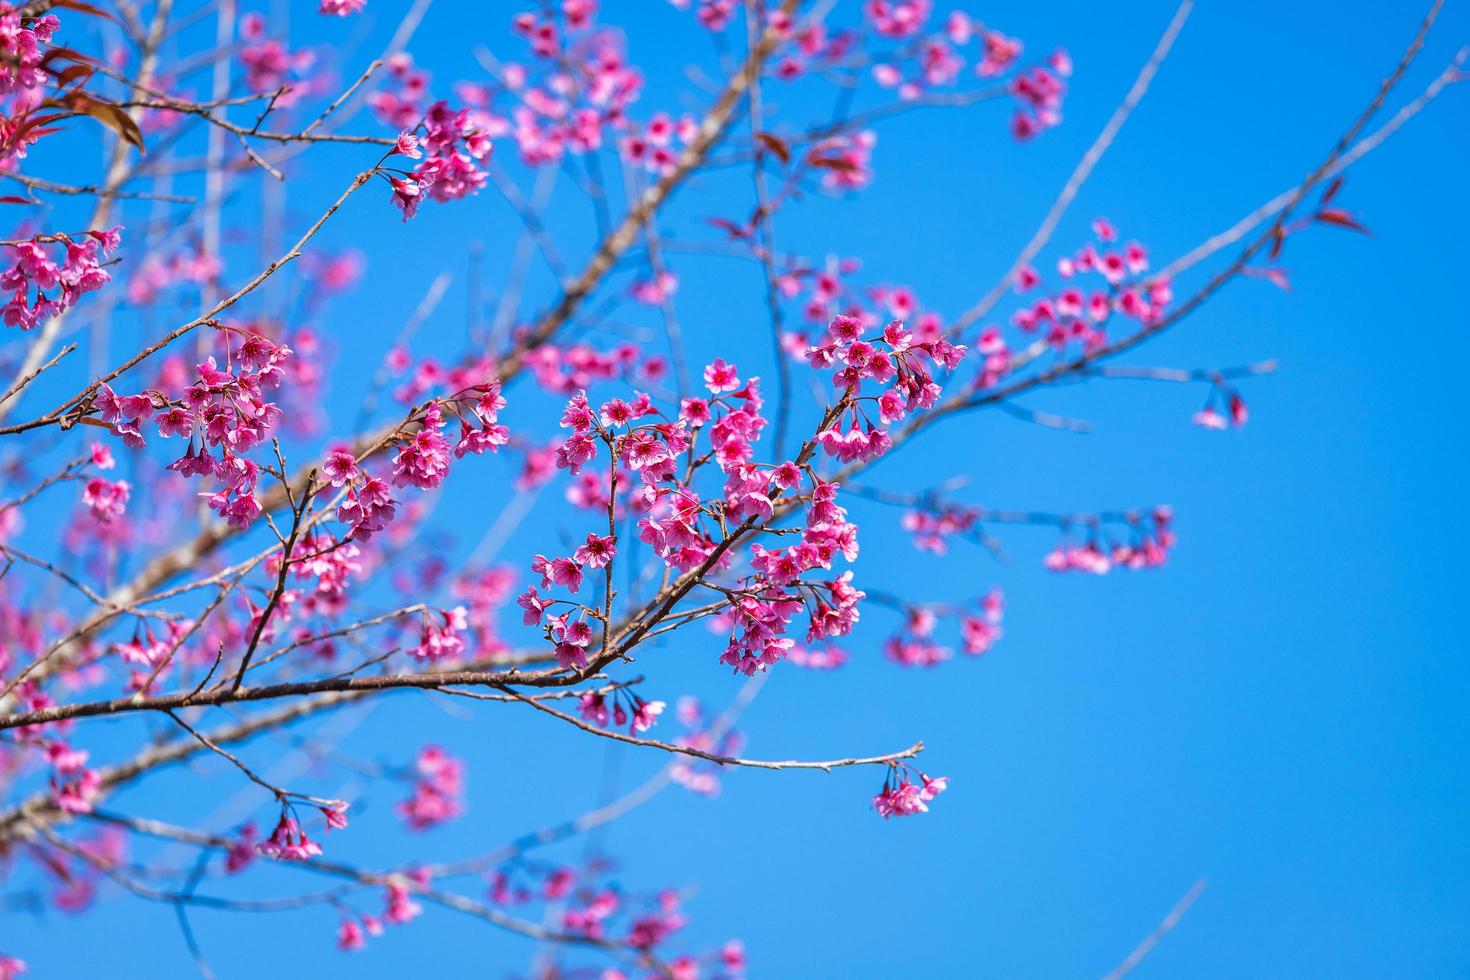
[11, 0, 1470, 977]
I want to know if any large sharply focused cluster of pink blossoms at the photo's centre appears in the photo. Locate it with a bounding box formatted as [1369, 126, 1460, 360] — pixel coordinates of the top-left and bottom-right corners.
[519, 339, 963, 690]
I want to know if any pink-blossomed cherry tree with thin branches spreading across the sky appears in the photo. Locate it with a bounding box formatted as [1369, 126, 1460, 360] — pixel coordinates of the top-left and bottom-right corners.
[0, 0, 1461, 979]
